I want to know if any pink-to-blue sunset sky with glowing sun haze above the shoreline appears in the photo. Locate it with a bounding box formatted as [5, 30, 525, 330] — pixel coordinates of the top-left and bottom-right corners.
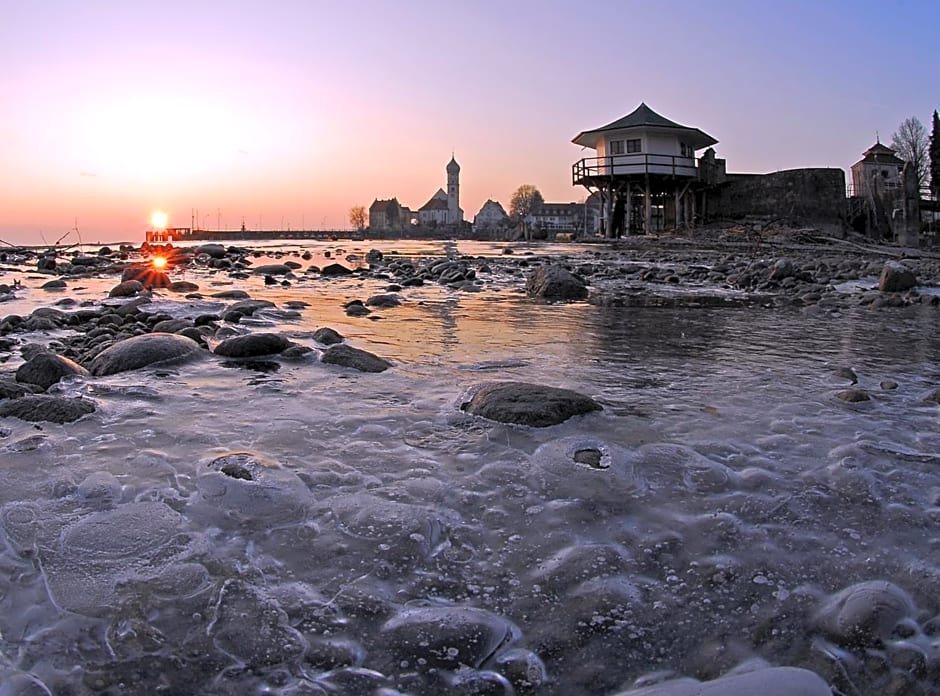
[0, 0, 940, 246]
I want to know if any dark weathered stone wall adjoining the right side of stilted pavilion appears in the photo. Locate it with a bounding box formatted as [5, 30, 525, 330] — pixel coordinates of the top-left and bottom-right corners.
[700, 168, 846, 227]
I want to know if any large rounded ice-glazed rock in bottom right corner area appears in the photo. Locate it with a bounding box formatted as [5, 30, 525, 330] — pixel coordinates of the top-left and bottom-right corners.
[813, 580, 915, 646]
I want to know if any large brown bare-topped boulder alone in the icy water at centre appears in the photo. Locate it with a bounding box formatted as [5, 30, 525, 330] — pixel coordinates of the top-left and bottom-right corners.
[460, 382, 603, 428]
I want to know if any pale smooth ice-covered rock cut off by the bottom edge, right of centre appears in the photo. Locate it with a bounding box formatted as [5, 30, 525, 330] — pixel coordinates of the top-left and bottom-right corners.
[615, 667, 832, 696]
